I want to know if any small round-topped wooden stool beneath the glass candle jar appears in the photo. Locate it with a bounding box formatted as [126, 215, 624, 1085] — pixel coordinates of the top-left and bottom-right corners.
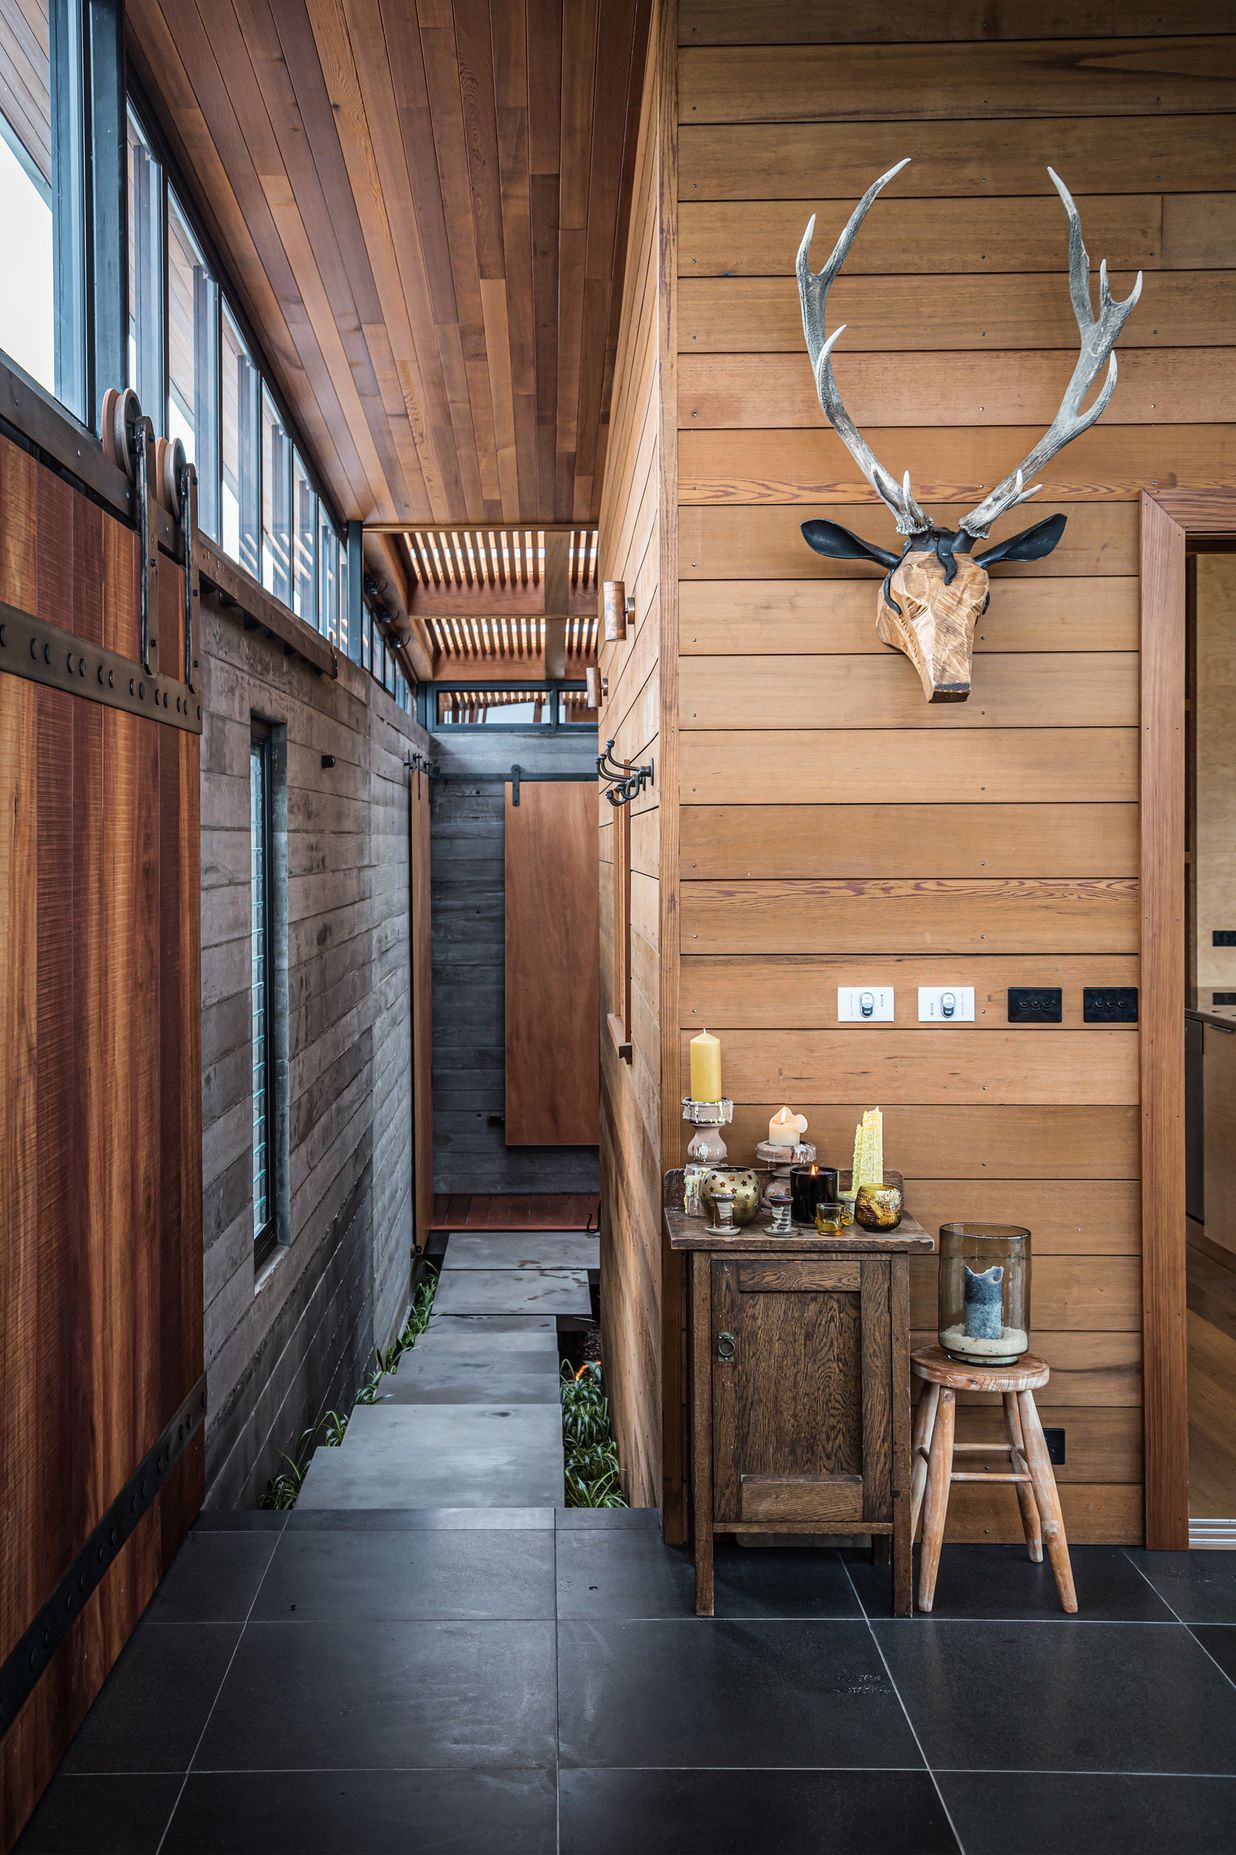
[909, 1347, 1076, 1614]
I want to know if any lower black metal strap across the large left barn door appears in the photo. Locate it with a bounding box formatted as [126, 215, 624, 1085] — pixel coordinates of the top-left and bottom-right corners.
[0, 1375, 206, 1738]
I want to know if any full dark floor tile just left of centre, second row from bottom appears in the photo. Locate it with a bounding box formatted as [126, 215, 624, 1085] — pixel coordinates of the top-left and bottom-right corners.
[195, 1621, 555, 1772]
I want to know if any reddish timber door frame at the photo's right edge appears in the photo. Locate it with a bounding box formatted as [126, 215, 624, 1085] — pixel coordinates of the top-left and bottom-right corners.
[1138, 488, 1236, 1551]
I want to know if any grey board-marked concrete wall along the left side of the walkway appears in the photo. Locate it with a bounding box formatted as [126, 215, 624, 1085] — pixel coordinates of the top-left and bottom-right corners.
[202, 612, 427, 1506]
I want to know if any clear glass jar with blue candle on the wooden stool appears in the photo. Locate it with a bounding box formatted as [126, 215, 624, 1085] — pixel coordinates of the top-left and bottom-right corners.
[939, 1224, 1030, 1365]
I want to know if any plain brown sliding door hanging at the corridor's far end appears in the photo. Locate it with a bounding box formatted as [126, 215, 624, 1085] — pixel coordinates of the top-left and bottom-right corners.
[507, 779, 599, 1146]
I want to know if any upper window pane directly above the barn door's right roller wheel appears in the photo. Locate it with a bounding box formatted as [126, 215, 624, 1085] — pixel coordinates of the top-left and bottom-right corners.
[167, 191, 219, 538]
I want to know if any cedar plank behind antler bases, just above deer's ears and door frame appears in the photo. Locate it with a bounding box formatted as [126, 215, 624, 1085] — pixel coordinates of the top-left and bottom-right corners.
[677, 424, 1236, 504]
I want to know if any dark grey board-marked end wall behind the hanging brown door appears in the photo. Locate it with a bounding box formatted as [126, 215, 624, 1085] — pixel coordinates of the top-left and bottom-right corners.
[431, 729, 599, 1193]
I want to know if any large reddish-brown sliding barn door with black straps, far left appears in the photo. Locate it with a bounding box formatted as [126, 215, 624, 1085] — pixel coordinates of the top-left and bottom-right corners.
[0, 440, 204, 1849]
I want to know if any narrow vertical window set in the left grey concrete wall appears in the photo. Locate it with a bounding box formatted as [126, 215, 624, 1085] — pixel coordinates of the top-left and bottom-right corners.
[249, 722, 277, 1265]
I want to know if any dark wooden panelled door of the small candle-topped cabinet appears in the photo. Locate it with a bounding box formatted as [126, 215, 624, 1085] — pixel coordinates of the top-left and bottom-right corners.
[713, 1258, 891, 1525]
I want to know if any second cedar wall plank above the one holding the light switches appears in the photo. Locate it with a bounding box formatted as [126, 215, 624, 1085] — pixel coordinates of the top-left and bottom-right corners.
[679, 803, 1138, 879]
